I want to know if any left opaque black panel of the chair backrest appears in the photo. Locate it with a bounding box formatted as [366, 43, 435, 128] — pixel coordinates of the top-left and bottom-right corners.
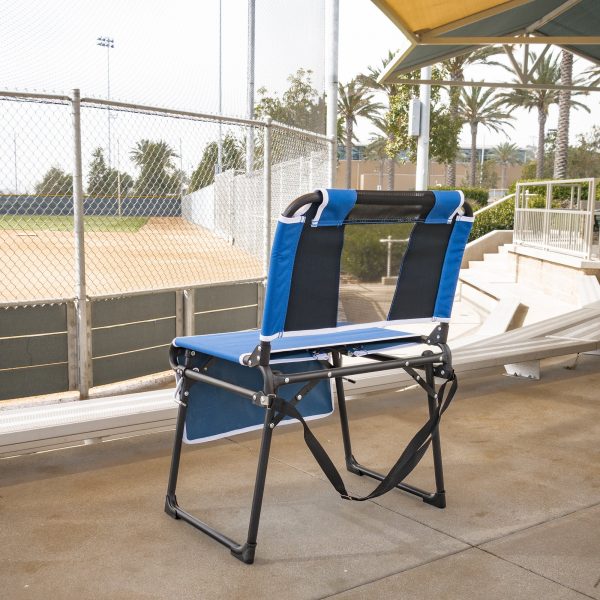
[285, 216, 344, 331]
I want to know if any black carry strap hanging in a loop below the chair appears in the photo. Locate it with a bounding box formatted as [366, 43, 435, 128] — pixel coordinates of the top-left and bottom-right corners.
[273, 374, 458, 502]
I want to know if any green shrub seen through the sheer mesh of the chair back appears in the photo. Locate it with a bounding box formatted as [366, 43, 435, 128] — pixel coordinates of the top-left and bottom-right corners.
[342, 224, 412, 282]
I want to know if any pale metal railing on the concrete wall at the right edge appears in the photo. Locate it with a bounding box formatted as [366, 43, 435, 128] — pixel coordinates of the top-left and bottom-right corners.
[513, 178, 600, 260]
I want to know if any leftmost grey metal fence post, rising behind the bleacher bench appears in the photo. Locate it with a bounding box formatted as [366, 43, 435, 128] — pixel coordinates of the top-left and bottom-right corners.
[71, 89, 90, 399]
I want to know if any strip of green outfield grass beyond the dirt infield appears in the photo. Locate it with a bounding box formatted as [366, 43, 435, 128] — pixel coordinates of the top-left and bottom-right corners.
[0, 215, 148, 233]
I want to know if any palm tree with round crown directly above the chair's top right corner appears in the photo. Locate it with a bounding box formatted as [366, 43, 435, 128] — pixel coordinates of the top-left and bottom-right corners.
[458, 87, 512, 186]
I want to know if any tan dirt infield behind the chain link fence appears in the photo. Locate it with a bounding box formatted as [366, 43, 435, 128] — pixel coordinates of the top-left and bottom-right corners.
[0, 217, 262, 302]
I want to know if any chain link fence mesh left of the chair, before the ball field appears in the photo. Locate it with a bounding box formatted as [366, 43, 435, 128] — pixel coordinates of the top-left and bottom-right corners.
[0, 92, 332, 304]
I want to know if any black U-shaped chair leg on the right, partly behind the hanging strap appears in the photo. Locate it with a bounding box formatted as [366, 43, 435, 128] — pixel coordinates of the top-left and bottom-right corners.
[333, 352, 446, 508]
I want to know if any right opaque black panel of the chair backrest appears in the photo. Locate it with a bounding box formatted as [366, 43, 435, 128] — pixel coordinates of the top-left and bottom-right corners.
[389, 223, 452, 320]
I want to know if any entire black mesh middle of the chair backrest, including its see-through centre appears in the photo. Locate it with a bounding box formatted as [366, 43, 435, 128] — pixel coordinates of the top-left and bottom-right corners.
[285, 191, 452, 331]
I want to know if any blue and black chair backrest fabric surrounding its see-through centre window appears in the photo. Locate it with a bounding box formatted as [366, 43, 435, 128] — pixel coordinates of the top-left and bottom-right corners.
[261, 190, 473, 341]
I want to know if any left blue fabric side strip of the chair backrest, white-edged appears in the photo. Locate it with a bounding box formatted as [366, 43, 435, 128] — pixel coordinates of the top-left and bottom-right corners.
[261, 222, 304, 336]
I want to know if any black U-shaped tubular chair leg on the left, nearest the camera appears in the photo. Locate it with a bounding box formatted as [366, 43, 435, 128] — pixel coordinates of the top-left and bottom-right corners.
[165, 378, 274, 564]
